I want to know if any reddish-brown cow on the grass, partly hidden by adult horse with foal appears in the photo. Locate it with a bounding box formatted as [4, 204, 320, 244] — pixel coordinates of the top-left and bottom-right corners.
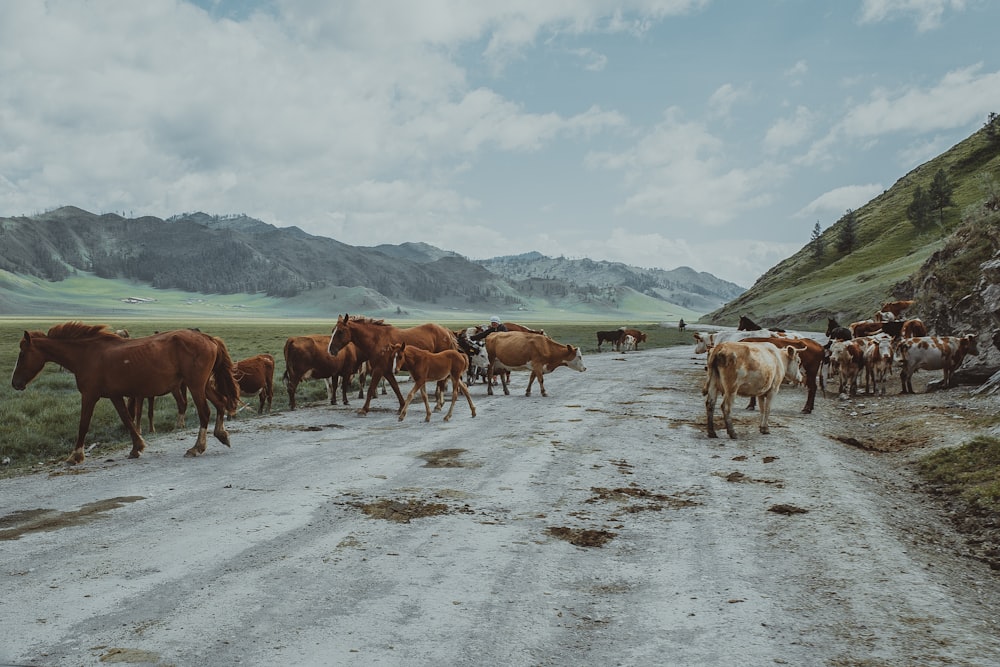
[281, 334, 359, 410]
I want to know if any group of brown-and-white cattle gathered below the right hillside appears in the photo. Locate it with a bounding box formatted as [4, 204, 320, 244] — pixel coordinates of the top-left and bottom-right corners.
[694, 301, 979, 438]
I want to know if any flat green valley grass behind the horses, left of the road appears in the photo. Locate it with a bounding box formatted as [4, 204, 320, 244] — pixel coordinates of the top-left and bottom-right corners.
[0, 318, 692, 478]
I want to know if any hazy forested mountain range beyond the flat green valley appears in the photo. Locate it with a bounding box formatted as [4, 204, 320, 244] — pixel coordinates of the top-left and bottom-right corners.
[0, 206, 739, 317]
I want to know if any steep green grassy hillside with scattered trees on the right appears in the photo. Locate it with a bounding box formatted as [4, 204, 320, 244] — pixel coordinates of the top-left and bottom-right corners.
[701, 121, 1000, 329]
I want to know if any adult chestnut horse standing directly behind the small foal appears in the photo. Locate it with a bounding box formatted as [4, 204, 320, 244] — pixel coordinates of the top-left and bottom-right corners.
[327, 314, 458, 415]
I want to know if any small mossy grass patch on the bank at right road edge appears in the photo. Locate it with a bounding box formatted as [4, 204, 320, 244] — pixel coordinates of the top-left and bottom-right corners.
[918, 436, 1000, 512]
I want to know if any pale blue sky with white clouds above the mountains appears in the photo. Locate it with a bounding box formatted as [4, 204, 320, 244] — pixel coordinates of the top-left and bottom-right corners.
[0, 0, 1000, 287]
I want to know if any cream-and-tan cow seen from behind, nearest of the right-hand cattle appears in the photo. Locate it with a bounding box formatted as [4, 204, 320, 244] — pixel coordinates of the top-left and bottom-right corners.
[702, 341, 802, 439]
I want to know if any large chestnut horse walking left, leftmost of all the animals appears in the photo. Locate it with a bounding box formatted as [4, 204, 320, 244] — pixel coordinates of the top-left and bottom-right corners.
[11, 322, 239, 464]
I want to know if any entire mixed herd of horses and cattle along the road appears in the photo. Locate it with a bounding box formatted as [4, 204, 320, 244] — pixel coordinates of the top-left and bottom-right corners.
[12, 301, 979, 463]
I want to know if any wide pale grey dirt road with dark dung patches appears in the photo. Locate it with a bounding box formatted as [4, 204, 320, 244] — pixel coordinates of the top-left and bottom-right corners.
[0, 348, 1000, 667]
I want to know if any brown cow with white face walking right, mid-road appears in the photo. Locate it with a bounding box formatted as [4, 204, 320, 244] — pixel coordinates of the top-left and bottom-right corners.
[486, 331, 587, 396]
